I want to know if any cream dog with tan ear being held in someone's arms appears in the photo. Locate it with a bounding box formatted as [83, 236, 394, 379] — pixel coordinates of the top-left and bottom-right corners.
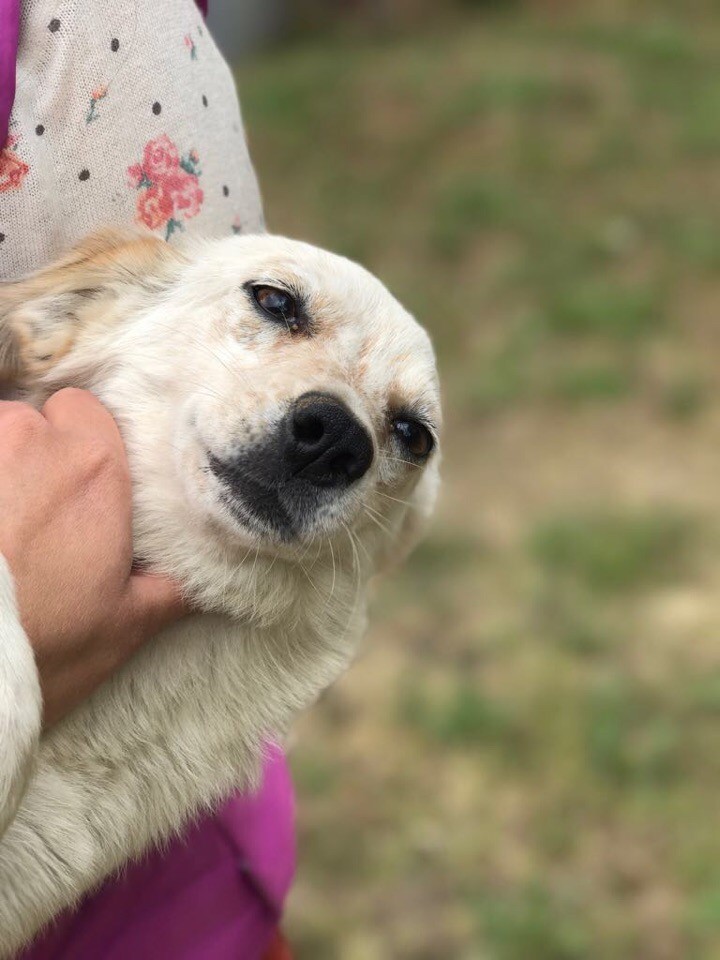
[0, 231, 440, 957]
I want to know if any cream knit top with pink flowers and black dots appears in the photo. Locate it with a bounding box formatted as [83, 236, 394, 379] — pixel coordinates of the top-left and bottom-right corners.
[0, 0, 263, 280]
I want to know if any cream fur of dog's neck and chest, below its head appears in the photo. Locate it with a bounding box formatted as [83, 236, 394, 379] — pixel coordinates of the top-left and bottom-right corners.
[0, 371, 365, 957]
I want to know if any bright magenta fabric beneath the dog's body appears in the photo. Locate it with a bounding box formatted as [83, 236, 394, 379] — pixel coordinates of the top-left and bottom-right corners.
[18, 748, 295, 960]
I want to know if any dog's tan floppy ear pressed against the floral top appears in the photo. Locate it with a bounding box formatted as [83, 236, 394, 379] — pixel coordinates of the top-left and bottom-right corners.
[0, 230, 184, 384]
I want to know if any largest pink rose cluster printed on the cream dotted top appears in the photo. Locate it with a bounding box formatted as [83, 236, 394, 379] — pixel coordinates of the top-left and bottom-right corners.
[127, 134, 204, 240]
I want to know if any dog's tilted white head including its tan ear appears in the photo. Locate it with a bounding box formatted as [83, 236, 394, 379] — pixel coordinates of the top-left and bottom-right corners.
[0, 234, 440, 616]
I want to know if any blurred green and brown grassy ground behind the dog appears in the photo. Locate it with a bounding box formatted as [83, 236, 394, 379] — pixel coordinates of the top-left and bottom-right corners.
[217, 0, 720, 960]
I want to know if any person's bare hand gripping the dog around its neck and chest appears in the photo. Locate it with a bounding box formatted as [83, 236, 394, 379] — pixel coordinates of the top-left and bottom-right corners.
[0, 389, 186, 726]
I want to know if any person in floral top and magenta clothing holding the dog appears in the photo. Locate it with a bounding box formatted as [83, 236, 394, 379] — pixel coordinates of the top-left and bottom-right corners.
[0, 0, 294, 960]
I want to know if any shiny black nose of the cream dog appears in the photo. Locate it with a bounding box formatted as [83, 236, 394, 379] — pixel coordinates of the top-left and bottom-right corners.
[284, 393, 373, 487]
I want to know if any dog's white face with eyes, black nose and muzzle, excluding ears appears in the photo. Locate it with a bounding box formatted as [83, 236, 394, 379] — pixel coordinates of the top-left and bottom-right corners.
[171, 237, 440, 550]
